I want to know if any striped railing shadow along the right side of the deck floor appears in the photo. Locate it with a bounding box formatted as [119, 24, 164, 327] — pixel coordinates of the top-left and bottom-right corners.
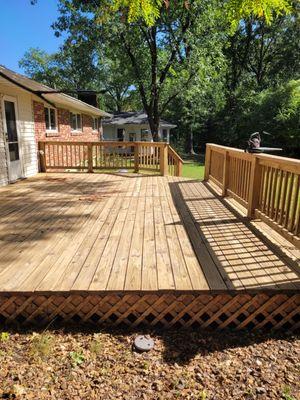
[170, 180, 300, 291]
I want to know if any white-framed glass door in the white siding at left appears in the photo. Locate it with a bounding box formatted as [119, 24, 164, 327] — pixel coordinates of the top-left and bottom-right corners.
[3, 96, 22, 182]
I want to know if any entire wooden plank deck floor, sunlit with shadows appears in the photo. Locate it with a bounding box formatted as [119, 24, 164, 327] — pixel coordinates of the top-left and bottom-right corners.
[0, 173, 300, 293]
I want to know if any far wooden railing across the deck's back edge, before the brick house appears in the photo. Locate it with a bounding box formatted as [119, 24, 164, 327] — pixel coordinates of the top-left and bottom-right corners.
[39, 141, 182, 176]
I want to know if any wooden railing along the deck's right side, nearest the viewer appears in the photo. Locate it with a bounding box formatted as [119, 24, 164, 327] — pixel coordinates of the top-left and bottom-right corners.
[205, 144, 300, 247]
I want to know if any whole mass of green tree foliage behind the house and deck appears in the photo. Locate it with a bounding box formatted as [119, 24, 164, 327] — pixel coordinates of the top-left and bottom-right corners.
[26, 0, 300, 156]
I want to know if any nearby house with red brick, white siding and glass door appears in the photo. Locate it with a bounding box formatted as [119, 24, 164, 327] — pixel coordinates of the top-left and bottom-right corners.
[0, 65, 111, 186]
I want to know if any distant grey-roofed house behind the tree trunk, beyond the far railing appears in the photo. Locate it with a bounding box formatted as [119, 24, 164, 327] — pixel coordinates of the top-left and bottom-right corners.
[103, 111, 176, 142]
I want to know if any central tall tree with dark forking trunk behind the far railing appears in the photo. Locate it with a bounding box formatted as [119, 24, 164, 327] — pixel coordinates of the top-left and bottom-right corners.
[54, 0, 225, 140]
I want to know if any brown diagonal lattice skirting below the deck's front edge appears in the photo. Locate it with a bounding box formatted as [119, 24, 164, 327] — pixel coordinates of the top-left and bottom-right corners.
[0, 292, 300, 331]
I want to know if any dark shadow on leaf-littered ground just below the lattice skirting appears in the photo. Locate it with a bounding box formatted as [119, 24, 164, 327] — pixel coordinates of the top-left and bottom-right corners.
[3, 322, 300, 366]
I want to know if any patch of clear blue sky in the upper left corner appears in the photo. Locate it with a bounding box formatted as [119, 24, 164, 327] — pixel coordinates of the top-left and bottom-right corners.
[0, 0, 62, 72]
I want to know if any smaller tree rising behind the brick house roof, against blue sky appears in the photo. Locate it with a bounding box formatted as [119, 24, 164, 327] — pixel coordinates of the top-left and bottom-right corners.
[19, 44, 141, 111]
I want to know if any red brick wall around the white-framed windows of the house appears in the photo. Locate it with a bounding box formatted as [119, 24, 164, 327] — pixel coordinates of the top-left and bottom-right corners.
[33, 101, 99, 142]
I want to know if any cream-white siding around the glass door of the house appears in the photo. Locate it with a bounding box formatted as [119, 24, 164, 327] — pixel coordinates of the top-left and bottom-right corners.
[0, 79, 38, 184]
